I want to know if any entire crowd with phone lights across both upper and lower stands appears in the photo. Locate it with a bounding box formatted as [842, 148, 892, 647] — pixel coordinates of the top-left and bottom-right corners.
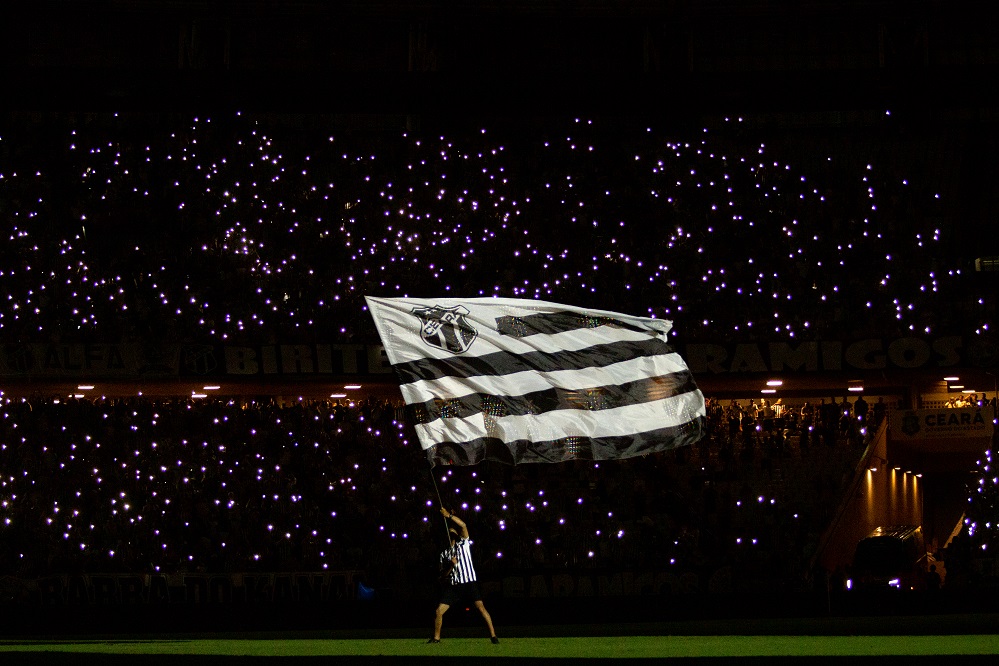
[0, 114, 995, 590]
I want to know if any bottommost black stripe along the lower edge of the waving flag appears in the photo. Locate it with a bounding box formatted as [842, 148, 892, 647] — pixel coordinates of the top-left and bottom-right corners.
[427, 416, 705, 467]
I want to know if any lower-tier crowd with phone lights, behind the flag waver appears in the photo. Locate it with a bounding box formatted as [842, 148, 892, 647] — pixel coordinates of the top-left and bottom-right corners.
[0, 390, 867, 594]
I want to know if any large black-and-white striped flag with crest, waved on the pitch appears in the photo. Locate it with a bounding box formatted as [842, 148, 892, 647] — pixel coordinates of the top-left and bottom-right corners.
[366, 297, 705, 466]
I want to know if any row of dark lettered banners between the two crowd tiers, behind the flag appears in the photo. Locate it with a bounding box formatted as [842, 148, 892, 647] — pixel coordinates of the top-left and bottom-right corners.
[0, 336, 976, 380]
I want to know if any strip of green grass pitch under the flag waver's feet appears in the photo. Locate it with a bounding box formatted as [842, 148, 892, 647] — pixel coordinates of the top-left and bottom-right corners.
[0, 614, 999, 666]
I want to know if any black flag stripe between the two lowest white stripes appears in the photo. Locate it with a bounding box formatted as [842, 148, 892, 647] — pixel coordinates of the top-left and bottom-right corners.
[406, 371, 697, 423]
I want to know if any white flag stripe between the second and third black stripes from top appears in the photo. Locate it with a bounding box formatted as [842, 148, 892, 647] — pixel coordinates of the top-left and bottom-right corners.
[400, 353, 687, 404]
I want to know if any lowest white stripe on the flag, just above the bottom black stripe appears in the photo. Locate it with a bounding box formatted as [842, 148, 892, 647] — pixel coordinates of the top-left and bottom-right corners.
[416, 391, 705, 450]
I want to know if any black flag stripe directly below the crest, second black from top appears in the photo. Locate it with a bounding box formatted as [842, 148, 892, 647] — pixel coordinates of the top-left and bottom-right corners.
[392, 338, 674, 384]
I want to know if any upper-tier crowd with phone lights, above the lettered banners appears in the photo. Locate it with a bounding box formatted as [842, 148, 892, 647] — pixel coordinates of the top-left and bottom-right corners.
[0, 113, 996, 343]
